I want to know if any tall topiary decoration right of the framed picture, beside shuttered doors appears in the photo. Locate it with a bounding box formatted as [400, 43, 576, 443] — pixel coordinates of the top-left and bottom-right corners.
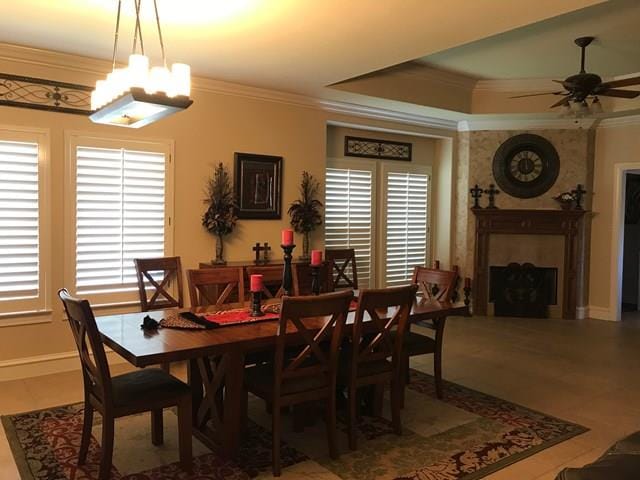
[289, 171, 323, 261]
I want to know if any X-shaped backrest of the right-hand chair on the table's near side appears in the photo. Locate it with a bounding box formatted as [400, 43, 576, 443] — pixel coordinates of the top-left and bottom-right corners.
[352, 285, 418, 375]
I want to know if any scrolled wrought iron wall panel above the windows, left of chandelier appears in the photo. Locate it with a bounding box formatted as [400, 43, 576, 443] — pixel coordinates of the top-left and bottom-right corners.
[0, 73, 92, 115]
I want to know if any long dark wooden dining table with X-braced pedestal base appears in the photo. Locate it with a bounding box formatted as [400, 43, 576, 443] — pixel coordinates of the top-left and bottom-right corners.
[96, 299, 469, 456]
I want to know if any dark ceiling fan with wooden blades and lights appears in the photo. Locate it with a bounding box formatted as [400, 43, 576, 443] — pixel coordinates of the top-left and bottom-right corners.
[511, 37, 640, 108]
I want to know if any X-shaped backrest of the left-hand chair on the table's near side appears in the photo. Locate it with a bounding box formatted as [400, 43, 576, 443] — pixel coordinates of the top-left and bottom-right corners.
[275, 291, 353, 394]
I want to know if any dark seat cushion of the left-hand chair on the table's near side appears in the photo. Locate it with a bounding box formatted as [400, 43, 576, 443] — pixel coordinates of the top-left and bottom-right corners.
[244, 363, 329, 399]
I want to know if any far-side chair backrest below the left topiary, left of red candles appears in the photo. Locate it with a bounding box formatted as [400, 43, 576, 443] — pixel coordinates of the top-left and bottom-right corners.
[187, 267, 245, 307]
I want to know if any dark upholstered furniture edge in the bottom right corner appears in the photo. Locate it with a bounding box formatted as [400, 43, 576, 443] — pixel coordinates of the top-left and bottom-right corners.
[556, 432, 640, 480]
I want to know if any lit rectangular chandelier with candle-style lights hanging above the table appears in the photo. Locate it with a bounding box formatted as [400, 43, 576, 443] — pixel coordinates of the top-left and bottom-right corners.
[89, 0, 193, 128]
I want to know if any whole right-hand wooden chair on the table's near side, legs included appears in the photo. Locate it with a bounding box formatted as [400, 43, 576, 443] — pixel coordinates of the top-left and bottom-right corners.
[338, 285, 418, 450]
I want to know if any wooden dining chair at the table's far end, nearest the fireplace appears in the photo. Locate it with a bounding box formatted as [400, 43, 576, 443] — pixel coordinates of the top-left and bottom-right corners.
[402, 266, 458, 399]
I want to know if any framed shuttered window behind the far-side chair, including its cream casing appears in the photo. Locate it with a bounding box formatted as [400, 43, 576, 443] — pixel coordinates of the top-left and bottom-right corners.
[65, 135, 173, 306]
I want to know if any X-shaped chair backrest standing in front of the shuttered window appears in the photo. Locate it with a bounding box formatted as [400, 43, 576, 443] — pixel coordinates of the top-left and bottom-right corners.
[133, 257, 184, 312]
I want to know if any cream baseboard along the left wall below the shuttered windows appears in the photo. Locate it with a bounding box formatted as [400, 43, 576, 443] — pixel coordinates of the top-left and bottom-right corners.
[0, 349, 126, 382]
